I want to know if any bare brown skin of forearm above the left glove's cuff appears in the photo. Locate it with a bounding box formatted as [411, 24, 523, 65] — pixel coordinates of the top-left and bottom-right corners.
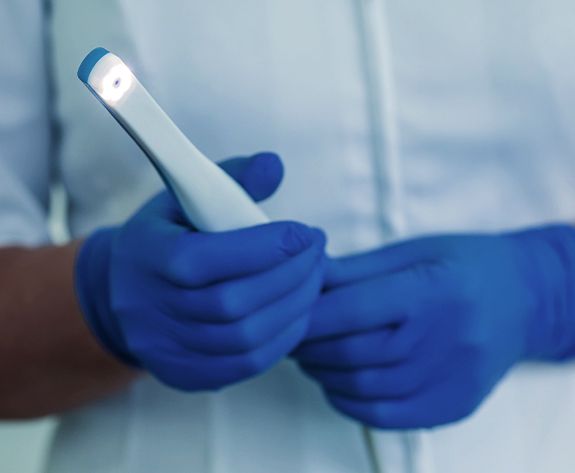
[0, 242, 138, 419]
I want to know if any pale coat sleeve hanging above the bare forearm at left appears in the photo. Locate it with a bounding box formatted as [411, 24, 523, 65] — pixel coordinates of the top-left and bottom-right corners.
[0, 0, 52, 246]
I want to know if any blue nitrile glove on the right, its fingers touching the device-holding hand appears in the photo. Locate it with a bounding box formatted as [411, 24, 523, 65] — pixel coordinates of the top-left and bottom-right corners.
[294, 226, 575, 429]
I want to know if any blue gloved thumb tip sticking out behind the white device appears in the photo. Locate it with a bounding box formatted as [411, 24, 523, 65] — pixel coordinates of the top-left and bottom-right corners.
[218, 153, 284, 202]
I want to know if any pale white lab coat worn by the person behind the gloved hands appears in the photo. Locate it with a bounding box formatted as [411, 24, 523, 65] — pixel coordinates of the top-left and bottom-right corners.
[0, 0, 575, 473]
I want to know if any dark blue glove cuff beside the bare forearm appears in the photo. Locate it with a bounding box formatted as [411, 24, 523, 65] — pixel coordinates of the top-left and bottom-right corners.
[74, 228, 138, 366]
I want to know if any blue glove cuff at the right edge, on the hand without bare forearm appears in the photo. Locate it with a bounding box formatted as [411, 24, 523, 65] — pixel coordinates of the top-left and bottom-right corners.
[511, 225, 575, 360]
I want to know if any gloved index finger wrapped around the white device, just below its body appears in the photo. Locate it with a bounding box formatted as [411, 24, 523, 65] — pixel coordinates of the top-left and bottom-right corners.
[161, 222, 325, 288]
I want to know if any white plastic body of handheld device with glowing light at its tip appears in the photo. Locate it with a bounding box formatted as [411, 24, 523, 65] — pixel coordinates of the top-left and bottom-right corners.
[79, 52, 269, 232]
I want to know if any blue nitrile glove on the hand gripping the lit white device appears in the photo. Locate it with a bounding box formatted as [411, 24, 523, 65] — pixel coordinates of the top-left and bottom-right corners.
[75, 154, 325, 391]
